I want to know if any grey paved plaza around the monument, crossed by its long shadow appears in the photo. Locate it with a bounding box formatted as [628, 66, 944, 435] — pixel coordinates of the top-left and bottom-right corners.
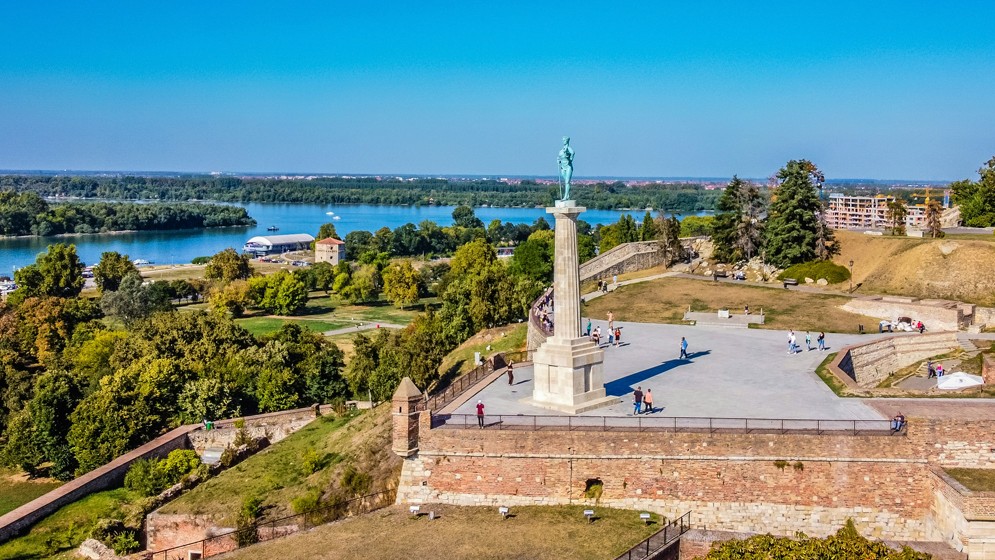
[455, 318, 893, 420]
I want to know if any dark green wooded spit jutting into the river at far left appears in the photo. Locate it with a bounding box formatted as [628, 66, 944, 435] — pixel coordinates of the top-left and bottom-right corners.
[0, 190, 256, 236]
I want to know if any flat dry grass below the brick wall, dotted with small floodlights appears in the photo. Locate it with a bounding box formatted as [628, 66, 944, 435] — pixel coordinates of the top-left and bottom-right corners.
[226, 505, 660, 560]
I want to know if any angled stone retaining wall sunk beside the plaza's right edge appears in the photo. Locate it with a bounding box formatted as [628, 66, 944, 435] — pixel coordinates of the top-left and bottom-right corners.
[832, 332, 960, 388]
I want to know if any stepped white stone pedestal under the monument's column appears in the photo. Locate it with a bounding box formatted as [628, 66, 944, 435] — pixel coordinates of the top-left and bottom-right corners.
[521, 337, 619, 414]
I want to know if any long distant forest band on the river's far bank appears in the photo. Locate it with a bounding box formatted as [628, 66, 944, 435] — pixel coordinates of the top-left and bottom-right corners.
[0, 175, 719, 214]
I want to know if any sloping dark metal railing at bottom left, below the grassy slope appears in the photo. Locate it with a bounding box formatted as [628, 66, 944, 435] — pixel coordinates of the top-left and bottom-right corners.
[144, 490, 395, 560]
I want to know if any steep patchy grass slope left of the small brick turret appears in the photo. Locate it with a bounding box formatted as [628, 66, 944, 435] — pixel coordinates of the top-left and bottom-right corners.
[162, 405, 401, 526]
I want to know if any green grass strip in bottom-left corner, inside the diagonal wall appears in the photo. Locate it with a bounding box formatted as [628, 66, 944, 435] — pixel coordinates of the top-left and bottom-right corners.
[0, 488, 139, 560]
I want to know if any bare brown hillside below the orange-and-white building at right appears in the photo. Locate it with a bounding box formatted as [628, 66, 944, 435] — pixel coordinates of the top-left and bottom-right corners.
[833, 231, 995, 306]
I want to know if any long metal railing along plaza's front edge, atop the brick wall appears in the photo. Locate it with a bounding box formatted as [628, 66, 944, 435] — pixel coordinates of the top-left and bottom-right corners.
[432, 414, 893, 435]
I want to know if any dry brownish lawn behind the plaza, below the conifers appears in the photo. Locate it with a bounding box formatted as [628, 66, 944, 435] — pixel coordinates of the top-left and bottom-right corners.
[583, 278, 877, 333]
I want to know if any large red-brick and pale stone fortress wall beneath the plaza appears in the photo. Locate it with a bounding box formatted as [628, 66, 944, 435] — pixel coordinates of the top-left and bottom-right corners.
[398, 413, 995, 540]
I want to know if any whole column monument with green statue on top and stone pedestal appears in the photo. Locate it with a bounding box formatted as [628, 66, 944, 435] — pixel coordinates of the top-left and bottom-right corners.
[525, 137, 618, 414]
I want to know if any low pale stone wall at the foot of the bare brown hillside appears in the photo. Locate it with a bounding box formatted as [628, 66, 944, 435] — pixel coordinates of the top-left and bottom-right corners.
[843, 296, 974, 332]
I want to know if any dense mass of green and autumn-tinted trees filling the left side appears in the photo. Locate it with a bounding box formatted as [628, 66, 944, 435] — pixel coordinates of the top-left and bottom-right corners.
[0, 244, 349, 479]
